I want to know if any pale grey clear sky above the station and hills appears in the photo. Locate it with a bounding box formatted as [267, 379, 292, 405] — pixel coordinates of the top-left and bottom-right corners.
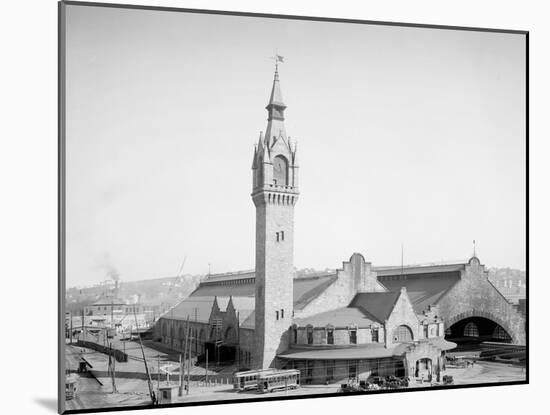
[66, 5, 526, 286]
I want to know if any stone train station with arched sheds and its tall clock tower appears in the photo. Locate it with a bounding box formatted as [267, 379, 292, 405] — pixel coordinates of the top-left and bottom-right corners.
[155, 64, 525, 383]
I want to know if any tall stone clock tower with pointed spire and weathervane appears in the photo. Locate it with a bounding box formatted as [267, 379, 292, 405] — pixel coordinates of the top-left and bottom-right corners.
[252, 66, 298, 368]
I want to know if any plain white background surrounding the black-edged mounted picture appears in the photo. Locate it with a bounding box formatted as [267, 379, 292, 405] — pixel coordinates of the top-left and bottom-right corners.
[0, 0, 550, 415]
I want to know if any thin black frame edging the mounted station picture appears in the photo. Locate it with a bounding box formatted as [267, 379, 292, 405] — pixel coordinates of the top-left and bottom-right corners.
[58, 0, 530, 414]
